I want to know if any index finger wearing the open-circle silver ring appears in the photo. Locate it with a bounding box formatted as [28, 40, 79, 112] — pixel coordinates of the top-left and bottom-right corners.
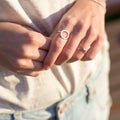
[44, 20, 72, 69]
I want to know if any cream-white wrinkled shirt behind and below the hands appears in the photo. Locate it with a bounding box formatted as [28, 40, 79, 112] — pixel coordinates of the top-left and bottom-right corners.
[0, 0, 109, 112]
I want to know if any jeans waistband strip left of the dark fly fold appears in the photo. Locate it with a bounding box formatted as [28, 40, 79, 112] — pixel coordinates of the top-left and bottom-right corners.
[0, 105, 56, 120]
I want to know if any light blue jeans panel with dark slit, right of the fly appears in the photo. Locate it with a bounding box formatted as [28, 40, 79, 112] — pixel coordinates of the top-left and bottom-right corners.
[58, 54, 111, 120]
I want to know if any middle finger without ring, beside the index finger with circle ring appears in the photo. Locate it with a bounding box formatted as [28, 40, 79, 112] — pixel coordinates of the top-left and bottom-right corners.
[56, 24, 88, 64]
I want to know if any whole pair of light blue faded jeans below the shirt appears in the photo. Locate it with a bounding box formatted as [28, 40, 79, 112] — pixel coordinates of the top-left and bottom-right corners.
[0, 44, 111, 120]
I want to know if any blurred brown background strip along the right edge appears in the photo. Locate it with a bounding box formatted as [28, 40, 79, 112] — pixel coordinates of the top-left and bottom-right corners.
[106, 0, 120, 120]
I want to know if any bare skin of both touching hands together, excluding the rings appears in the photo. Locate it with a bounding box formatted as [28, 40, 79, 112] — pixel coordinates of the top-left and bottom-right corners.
[0, 0, 105, 77]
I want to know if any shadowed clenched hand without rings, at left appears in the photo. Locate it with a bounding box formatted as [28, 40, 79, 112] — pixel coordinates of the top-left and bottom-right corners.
[0, 22, 50, 76]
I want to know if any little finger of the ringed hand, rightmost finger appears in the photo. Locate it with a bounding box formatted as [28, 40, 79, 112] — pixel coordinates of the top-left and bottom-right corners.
[82, 38, 103, 61]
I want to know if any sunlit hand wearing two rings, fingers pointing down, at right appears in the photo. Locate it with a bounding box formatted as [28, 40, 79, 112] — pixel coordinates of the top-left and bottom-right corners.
[44, 0, 105, 69]
